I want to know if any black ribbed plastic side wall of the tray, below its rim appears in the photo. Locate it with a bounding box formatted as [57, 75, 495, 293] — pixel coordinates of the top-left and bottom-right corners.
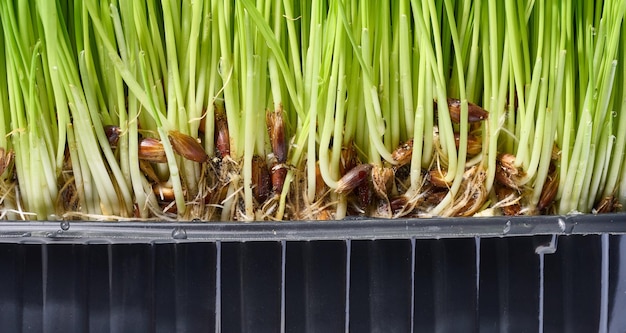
[0, 234, 626, 332]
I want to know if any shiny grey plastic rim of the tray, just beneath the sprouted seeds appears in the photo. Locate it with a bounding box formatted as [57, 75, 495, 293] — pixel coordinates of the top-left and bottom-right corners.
[0, 213, 626, 244]
